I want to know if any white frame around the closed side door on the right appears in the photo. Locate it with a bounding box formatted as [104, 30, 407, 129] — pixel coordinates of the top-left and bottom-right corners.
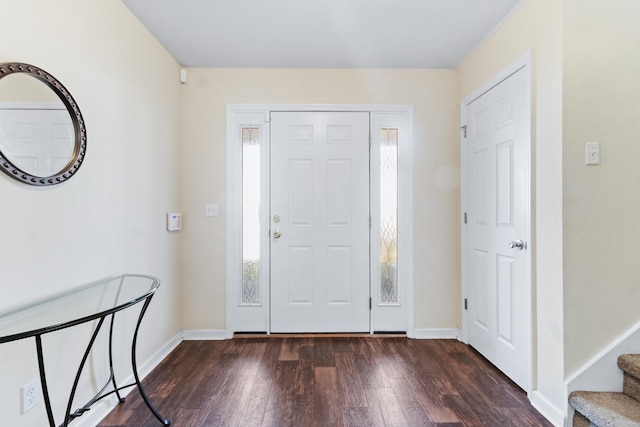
[460, 51, 536, 395]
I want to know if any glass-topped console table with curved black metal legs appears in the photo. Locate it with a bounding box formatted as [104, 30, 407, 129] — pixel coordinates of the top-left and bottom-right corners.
[0, 274, 171, 427]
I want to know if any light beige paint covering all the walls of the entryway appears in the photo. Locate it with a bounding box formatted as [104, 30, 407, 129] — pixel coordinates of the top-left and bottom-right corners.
[11, 0, 640, 427]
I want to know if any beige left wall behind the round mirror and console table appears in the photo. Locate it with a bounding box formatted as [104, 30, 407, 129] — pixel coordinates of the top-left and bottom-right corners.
[0, 0, 181, 427]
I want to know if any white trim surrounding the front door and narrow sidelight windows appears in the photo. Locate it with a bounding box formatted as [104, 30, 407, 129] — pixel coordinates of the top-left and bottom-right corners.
[225, 104, 415, 338]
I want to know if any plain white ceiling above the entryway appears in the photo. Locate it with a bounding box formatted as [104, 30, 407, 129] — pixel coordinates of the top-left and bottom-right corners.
[122, 0, 522, 68]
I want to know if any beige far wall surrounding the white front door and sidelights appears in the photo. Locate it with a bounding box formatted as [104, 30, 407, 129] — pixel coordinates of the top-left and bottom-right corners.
[182, 69, 460, 329]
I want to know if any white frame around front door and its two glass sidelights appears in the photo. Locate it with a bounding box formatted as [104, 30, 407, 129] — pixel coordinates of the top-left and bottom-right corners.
[225, 104, 414, 338]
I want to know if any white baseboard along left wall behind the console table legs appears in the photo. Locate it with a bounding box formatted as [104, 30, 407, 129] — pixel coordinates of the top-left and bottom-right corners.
[73, 332, 183, 427]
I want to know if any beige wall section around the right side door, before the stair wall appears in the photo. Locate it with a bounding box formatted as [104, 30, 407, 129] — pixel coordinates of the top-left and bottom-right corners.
[458, 0, 564, 416]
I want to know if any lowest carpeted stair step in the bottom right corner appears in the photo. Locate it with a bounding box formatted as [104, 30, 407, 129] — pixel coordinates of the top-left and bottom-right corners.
[569, 391, 640, 427]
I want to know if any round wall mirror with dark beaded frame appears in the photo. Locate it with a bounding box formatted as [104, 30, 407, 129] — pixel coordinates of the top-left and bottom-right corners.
[0, 63, 87, 186]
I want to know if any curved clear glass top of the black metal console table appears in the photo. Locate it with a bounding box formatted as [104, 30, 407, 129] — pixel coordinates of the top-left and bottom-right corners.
[0, 274, 160, 343]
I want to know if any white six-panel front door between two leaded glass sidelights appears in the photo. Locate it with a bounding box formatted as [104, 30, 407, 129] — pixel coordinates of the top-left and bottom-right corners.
[270, 112, 369, 333]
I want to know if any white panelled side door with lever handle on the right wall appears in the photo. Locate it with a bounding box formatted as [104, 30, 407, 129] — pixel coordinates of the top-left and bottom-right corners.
[462, 67, 531, 391]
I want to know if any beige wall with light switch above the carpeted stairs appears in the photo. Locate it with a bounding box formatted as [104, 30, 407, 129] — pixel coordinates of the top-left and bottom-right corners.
[563, 0, 640, 374]
